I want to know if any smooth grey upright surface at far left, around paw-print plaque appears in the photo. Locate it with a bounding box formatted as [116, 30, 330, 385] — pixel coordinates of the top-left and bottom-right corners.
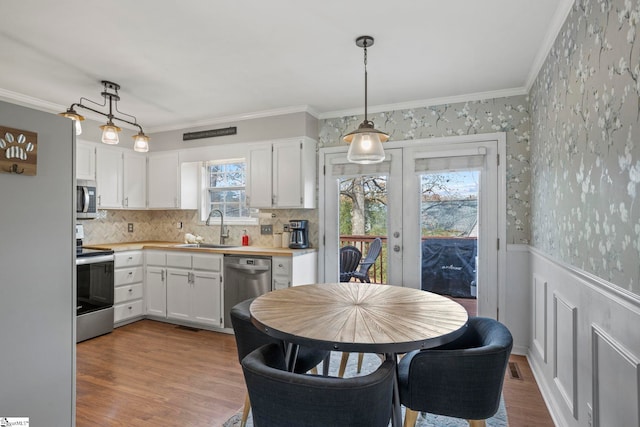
[0, 102, 75, 426]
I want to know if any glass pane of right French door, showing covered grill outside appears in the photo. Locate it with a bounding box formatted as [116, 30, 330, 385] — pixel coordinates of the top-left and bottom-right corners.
[420, 170, 480, 298]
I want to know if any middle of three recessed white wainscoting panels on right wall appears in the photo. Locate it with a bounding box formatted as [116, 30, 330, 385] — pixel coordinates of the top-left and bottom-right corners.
[553, 292, 578, 417]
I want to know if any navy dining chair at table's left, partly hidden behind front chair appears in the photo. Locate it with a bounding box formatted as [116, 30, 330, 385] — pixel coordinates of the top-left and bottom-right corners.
[230, 298, 331, 426]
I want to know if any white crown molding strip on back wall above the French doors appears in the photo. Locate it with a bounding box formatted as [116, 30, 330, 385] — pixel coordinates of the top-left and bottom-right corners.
[317, 87, 528, 120]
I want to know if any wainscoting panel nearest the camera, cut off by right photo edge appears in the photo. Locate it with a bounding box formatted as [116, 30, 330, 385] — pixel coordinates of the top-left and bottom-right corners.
[591, 325, 640, 427]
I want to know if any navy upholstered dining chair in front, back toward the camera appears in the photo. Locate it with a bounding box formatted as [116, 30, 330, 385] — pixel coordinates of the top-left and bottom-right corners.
[242, 344, 395, 427]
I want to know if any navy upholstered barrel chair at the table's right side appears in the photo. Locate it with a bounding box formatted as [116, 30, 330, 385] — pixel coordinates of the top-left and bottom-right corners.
[398, 317, 513, 427]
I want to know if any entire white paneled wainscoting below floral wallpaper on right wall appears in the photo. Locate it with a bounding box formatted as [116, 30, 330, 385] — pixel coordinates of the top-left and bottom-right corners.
[528, 248, 640, 427]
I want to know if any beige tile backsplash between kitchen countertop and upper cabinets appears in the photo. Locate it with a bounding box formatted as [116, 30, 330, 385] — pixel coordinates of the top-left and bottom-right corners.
[82, 209, 319, 247]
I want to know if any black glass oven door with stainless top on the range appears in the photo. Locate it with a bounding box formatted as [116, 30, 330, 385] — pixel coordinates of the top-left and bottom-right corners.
[76, 255, 114, 315]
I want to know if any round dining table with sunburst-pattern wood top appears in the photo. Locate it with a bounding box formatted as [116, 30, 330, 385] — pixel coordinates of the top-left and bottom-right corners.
[250, 282, 468, 426]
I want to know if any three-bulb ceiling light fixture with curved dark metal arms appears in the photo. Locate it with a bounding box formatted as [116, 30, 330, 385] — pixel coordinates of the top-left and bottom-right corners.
[59, 80, 149, 153]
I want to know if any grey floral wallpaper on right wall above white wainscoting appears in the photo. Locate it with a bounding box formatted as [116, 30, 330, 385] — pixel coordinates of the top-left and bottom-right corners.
[530, 0, 640, 294]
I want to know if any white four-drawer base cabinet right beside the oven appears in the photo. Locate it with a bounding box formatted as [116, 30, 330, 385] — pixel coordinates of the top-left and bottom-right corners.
[113, 251, 144, 326]
